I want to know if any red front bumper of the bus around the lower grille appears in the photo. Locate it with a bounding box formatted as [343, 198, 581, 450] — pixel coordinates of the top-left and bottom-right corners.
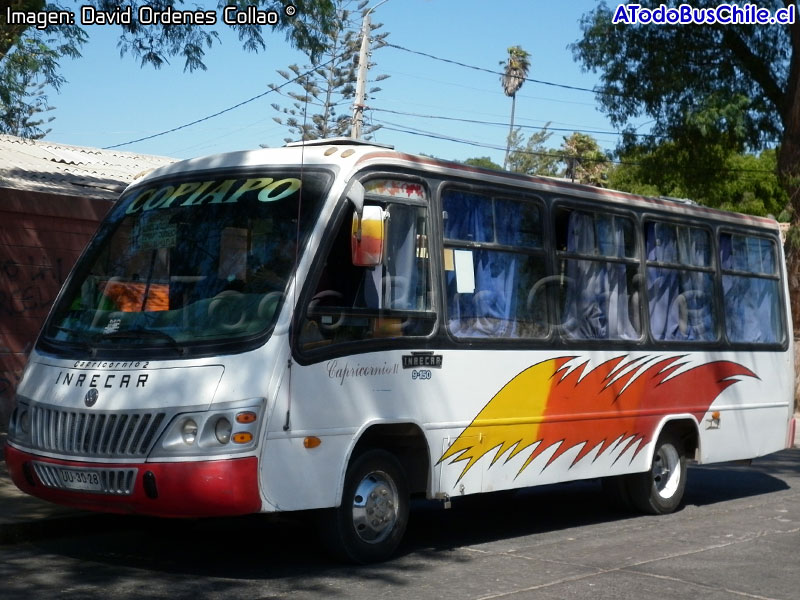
[5, 445, 261, 517]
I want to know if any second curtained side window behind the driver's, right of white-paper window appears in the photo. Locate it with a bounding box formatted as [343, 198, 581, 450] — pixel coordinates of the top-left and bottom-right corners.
[555, 209, 641, 340]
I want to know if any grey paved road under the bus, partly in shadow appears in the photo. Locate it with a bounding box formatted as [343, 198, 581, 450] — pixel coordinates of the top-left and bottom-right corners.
[0, 448, 800, 600]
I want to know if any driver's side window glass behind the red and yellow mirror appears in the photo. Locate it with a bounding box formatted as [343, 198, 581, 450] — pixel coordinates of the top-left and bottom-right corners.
[300, 203, 436, 350]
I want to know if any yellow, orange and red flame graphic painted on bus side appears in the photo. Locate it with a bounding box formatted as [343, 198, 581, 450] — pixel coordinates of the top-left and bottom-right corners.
[439, 356, 757, 480]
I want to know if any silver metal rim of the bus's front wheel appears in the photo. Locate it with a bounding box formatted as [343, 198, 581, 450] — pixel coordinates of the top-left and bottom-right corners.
[353, 471, 399, 544]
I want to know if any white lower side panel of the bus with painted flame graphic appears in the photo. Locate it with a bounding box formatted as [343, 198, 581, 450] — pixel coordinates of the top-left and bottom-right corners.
[262, 349, 791, 510]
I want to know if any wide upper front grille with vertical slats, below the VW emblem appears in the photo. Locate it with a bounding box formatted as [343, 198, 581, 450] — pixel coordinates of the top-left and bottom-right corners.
[30, 405, 166, 458]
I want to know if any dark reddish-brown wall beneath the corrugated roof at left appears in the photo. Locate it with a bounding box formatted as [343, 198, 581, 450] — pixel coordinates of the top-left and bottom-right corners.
[0, 189, 112, 431]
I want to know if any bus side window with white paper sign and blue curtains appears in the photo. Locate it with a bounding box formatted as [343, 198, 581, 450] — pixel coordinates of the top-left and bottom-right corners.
[442, 190, 549, 339]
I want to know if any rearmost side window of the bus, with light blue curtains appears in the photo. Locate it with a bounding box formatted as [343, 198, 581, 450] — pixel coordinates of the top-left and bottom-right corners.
[719, 233, 783, 344]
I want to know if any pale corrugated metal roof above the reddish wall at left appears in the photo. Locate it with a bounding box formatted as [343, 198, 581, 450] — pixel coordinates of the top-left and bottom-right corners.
[0, 135, 177, 200]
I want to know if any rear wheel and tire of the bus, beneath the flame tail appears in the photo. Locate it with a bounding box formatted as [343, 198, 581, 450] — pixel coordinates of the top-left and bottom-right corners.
[627, 433, 687, 515]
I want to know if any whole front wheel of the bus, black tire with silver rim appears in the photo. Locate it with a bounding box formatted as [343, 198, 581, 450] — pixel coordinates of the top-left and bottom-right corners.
[321, 450, 409, 564]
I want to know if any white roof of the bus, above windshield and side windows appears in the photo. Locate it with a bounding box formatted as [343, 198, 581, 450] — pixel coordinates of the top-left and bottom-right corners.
[136, 138, 779, 229]
